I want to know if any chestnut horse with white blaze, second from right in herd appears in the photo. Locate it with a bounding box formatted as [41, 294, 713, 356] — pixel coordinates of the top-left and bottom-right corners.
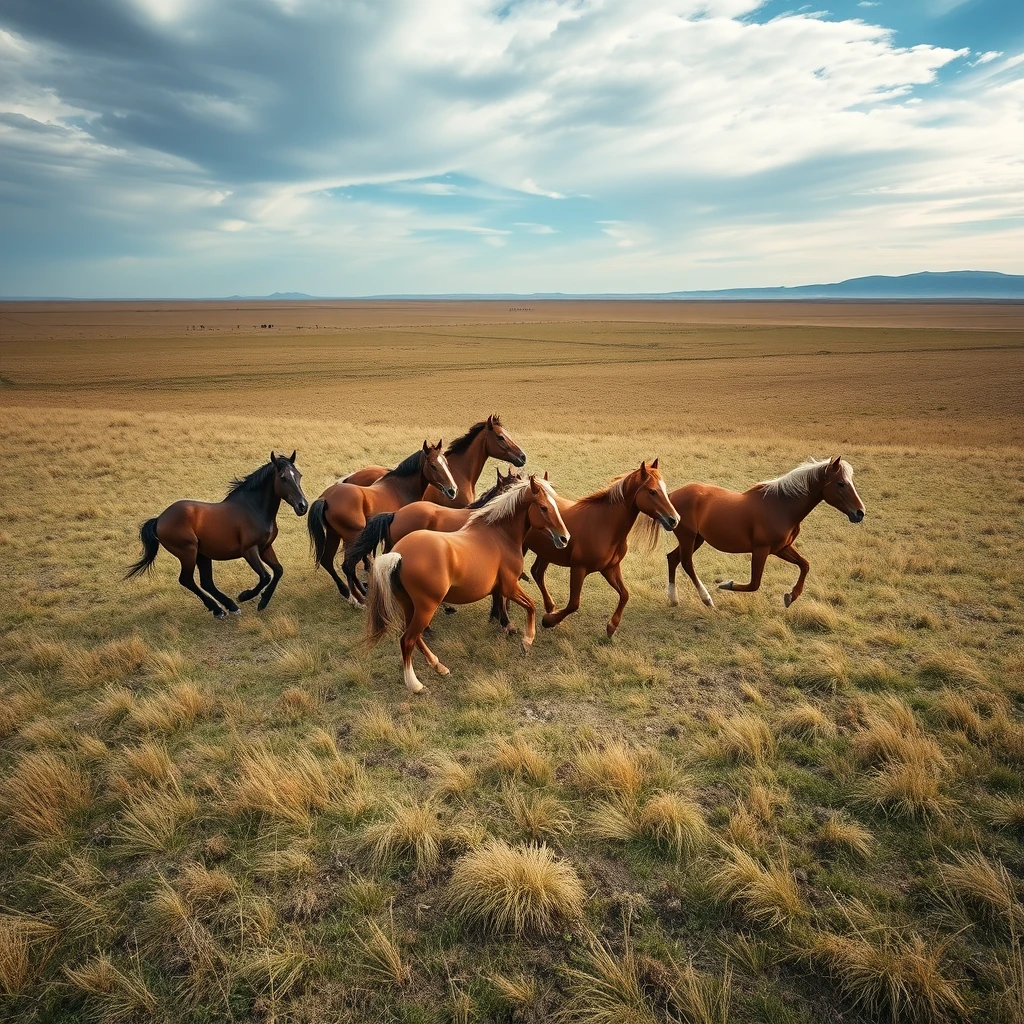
[526, 459, 679, 637]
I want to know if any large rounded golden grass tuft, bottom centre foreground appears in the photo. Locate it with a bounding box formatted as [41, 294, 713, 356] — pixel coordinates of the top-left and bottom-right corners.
[446, 840, 587, 936]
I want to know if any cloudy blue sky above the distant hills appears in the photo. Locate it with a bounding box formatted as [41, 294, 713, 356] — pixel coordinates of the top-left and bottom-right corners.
[0, 0, 1024, 298]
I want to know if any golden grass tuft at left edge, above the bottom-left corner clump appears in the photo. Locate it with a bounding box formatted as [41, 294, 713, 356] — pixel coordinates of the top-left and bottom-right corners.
[0, 752, 93, 843]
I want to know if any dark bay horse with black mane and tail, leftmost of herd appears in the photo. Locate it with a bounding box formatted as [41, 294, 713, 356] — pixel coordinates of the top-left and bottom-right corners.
[125, 452, 309, 618]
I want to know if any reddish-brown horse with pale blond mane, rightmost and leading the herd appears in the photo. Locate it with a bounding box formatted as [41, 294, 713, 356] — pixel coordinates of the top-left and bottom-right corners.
[669, 456, 864, 608]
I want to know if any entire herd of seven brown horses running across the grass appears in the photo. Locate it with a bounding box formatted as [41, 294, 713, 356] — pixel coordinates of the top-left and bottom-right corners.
[127, 416, 864, 692]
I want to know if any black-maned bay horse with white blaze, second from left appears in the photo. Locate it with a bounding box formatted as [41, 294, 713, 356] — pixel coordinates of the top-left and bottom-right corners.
[306, 441, 458, 604]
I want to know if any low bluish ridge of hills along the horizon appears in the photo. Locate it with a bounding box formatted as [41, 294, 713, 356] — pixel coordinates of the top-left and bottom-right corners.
[0, 270, 1024, 302]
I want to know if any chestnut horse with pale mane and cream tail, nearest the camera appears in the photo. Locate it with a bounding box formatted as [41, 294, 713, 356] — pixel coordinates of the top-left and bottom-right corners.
[367, 476, 569, 693]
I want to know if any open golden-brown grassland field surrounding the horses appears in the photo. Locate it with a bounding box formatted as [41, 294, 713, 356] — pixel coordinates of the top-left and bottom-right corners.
[0, 302, 1024, 1024]
